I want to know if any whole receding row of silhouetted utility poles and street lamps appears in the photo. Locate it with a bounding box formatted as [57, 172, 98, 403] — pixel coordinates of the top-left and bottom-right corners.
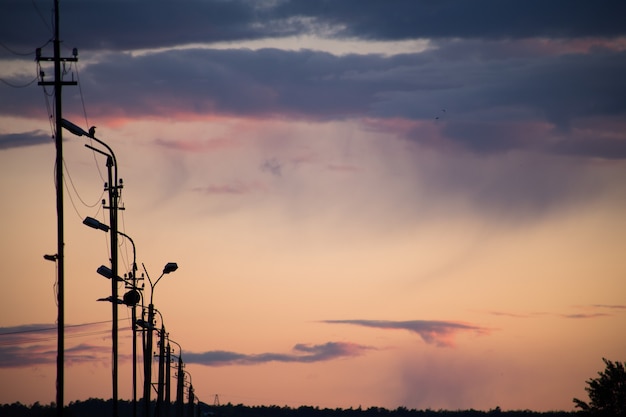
[36, 0, 197, 417]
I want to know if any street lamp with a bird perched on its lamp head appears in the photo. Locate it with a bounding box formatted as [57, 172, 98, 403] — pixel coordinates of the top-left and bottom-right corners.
[60, 119, 122, 417]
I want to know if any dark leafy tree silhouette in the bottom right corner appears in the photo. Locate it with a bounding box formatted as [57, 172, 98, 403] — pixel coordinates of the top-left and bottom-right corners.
[573, 358, 626, 416]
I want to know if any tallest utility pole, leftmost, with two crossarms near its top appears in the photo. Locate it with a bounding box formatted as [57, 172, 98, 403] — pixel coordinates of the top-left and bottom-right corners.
[36, 0, 78, 417]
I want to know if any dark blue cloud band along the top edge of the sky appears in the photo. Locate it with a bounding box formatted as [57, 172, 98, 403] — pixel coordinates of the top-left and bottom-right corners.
[0, 0, 626, 51]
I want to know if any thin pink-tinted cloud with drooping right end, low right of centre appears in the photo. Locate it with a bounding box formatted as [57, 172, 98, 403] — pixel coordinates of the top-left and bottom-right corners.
[323, 320, 491, 347]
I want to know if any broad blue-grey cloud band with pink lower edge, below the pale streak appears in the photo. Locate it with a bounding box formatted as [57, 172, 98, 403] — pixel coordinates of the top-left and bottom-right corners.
[0, 41, 626, 159]
